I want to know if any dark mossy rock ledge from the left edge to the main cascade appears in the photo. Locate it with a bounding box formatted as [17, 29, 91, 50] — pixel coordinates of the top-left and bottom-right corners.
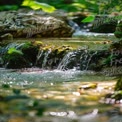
[0, 41, 72, 69]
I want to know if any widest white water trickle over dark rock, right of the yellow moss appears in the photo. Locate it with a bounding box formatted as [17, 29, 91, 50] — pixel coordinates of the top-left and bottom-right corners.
[57, 49, 98, 71]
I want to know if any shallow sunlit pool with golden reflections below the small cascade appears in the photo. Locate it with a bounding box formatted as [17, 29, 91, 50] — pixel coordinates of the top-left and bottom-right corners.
[0, 68, 121, 122]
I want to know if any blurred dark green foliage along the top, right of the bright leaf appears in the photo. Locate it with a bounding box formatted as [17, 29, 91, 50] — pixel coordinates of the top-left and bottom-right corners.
[38, 0, 122, 14]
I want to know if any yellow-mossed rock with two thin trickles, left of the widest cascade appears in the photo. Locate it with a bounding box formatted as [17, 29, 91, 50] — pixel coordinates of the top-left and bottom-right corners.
[36, 45, 72, 69]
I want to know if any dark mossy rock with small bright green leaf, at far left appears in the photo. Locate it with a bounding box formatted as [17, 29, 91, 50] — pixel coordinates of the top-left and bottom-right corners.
[1, 42, 38, 69]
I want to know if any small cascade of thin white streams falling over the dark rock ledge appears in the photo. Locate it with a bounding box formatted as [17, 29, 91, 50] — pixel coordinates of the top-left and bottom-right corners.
[36, 46, 98, 71]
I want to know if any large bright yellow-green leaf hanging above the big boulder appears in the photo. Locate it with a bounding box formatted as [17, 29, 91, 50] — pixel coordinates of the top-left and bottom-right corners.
[22, 0, 56, 13]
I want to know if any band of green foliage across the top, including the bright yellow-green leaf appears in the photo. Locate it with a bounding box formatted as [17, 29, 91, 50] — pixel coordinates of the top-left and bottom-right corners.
[0, 0, 122, 14]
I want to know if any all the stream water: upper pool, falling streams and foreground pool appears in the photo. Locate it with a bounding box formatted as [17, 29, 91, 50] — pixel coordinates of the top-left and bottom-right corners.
[0, 33, 122, 122]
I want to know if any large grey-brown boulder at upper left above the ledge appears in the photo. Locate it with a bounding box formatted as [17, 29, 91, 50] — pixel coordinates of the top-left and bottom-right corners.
[0, 10, 73, 37]
